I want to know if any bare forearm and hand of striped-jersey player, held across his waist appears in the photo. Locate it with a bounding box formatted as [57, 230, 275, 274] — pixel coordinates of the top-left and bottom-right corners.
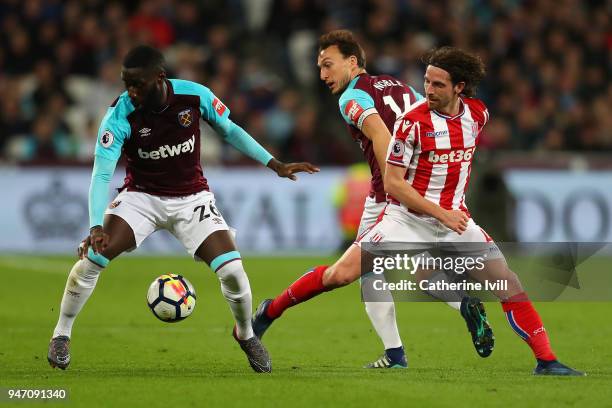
[384, 163, 469, 234]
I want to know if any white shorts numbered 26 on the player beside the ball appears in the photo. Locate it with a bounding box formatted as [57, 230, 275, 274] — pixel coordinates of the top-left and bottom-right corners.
[105, 190, 233, 261]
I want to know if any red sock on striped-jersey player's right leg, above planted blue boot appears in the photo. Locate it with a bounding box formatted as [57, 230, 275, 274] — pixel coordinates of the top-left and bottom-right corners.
[502, 292, 557, 361]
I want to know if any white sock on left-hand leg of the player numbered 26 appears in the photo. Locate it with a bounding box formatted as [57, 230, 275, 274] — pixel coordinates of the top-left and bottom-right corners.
[53, 258, 103, 337]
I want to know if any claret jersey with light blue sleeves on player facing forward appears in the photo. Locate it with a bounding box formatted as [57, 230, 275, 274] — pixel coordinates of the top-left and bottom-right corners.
[89, 79, 272, 226]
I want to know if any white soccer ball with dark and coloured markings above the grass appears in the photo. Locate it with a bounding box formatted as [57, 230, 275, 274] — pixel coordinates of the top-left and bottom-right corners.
[147, 273, 196, 323]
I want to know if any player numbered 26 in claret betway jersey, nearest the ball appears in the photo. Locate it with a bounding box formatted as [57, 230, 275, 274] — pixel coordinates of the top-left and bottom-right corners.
[48, 46, 318, 372]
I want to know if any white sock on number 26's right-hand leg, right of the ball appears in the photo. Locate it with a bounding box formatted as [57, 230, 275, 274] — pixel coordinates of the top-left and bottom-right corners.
[217, 259, 255, 340]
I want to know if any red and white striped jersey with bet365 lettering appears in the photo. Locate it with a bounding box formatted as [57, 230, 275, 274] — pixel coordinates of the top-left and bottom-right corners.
[387, 98, 489, 215]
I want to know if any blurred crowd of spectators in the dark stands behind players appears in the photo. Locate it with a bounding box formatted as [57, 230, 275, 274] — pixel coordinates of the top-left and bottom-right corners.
[0, 0, 612, 165]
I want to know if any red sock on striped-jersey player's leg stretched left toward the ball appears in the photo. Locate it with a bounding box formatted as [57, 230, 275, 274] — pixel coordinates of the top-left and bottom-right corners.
[266, 266, 328, 319]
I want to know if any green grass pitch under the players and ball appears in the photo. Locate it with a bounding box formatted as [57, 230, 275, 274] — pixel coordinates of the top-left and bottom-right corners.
[0, 256, 612, 408]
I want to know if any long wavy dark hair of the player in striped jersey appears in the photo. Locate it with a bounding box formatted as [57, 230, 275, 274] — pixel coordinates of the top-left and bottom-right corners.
[421, 46, 486, 97]
